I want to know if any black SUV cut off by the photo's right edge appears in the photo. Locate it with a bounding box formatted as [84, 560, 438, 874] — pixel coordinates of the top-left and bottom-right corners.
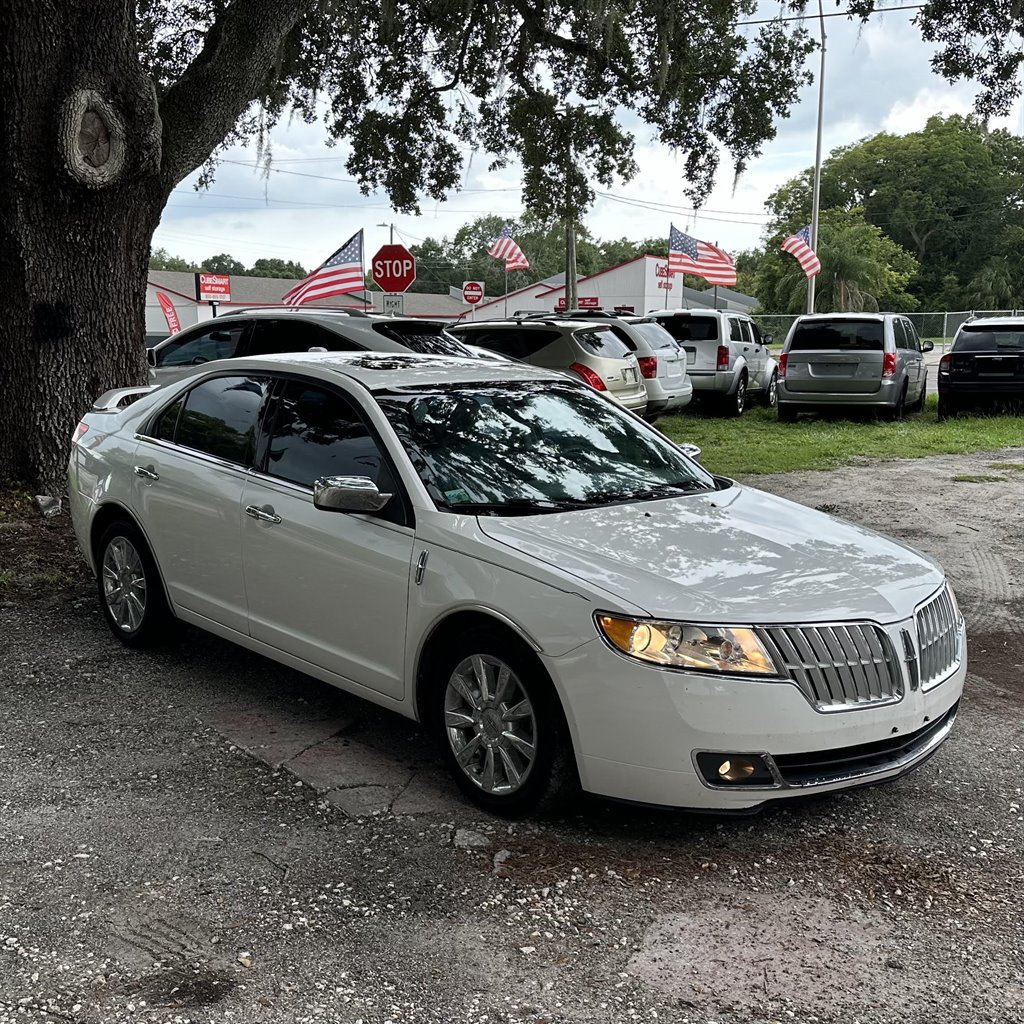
[939, 316, 1024, 420]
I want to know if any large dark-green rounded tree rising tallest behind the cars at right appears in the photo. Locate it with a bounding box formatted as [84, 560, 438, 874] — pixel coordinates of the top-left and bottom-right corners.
[768, 116, 1024, 308]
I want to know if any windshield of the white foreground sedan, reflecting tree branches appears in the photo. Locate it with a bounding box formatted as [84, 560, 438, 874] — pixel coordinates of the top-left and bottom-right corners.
[375, 381, 717, 515]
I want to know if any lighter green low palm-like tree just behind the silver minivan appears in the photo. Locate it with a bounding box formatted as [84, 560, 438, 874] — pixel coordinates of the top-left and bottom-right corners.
[754, 209, 918, 313]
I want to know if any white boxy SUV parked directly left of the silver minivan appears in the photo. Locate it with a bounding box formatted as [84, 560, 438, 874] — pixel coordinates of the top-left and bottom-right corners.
[648, 309, 778, 416]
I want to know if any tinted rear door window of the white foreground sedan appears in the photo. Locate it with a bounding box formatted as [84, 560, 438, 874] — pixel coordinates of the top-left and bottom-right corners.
[176, 377, 267, 466]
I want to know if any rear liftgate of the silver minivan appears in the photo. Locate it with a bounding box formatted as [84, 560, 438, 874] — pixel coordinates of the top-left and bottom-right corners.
[785, 317, 885, 394]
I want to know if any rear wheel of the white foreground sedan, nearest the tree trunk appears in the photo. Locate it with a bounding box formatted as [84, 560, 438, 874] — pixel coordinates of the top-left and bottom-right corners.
[96, 519, 176, 647]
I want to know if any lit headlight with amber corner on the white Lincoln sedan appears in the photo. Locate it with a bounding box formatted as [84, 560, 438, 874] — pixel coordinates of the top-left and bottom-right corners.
[595, 614, 778, 676]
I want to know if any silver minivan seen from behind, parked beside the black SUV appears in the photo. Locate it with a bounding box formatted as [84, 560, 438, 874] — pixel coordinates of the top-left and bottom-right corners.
[778, 313, 934, 422]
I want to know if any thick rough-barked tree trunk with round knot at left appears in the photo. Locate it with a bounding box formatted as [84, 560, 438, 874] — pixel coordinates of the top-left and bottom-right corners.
[0, 0, 168, 493]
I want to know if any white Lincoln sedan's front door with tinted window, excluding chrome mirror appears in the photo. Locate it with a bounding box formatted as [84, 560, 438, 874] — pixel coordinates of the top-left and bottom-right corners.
[242, 380, 415, 698]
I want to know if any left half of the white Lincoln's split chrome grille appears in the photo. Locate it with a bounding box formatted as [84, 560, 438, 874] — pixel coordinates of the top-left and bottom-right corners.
[764, 623, 903, 711]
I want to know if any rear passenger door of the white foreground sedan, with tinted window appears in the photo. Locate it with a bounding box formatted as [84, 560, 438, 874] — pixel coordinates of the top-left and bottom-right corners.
[133, 374, 269, 633]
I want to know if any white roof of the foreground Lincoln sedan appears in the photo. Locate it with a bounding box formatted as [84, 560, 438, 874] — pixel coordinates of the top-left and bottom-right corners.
[203, 352, 570, 391]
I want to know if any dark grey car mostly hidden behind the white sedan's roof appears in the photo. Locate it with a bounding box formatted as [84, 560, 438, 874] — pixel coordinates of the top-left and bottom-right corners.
[146, 306, 470, 384]
